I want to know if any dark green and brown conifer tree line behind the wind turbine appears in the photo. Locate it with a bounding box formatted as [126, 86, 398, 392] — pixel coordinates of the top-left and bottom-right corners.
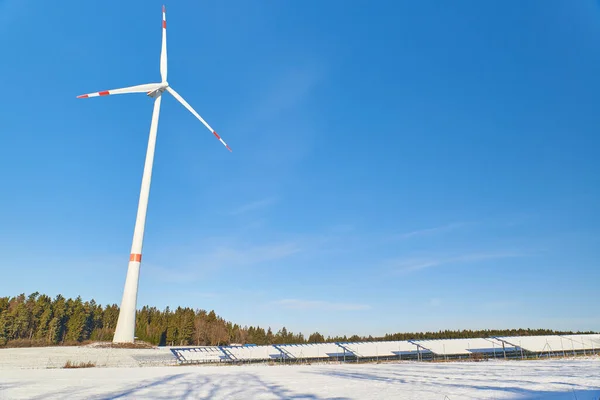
[0, 292, 593, 347]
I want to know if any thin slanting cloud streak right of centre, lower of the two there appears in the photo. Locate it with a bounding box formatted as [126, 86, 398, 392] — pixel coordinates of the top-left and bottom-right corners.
[387, 251, 526, 273]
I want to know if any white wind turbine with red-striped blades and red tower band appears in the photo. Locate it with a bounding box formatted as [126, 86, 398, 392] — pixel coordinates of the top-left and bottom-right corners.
[77, 6, 231, 343]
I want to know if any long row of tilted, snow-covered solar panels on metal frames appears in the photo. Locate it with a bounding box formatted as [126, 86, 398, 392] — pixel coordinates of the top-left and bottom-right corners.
[171, 334, 600, 363]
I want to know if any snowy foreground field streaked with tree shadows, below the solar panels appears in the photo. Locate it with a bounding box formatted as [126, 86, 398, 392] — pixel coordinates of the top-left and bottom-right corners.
[0, 358, 600, 400]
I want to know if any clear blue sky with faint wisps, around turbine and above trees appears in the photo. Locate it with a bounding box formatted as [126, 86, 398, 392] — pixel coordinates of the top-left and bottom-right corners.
[0, 0, 600, 335]
